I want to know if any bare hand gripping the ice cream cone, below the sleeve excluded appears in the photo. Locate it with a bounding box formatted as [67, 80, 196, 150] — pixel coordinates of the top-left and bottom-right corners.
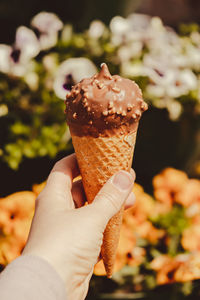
[23, 155, 134, 300]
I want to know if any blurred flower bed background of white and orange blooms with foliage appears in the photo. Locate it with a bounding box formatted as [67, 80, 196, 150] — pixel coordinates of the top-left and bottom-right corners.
[0, 0, 200, 299]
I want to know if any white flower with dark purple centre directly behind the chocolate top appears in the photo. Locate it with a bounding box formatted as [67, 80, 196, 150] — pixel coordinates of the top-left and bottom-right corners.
[53, 57, 97, 100]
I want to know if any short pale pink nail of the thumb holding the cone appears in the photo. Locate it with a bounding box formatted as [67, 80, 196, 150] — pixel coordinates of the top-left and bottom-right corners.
[112, 171, 133, 191]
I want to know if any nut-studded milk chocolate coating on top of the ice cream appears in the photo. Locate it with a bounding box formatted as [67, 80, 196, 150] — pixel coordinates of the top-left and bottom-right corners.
[66, 64, 148, 137]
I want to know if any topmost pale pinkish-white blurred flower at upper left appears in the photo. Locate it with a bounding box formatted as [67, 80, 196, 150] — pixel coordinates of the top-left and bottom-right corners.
[31, 12, 63, 50]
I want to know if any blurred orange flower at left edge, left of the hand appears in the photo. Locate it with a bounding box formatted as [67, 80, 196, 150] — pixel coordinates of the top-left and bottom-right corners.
[0, 191, 36, 265]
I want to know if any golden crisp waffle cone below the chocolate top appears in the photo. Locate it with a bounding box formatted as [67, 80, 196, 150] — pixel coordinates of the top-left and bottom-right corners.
[72, 130, 137, 277]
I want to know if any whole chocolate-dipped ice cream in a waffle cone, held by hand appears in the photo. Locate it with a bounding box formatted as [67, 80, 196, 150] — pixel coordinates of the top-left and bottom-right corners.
[66, 64, 147, 277]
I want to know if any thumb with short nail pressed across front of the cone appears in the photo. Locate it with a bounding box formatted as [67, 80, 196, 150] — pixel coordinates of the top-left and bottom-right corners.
[91, 171, 135, 226]
